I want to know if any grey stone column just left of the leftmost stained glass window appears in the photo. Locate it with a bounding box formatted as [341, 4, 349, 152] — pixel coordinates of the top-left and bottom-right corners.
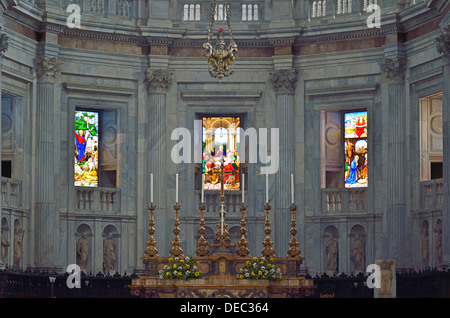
[35, 55, 62, 269]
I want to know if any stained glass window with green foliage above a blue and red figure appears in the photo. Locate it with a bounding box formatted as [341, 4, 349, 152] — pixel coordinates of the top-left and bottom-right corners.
[74, 111, 99, 187]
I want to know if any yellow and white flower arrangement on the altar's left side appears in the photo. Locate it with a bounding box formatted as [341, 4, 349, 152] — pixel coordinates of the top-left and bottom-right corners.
[159, 256, 202, 280]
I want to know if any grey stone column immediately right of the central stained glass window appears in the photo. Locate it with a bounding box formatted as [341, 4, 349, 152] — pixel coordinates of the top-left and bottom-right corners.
[270, 69, 297, 257]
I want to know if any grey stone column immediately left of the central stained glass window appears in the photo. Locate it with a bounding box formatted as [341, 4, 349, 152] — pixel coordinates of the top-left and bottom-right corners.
[144, 69, 173, 256]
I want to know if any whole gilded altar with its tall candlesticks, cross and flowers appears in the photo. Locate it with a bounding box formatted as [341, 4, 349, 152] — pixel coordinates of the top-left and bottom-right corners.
[129, 163, 315, 298]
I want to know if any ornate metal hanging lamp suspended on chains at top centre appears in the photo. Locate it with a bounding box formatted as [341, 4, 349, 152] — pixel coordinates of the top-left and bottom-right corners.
[203, 0, 238, 80]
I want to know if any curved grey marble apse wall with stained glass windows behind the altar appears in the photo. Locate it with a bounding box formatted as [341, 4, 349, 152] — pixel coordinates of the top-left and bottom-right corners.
[0, 0, 450, 300]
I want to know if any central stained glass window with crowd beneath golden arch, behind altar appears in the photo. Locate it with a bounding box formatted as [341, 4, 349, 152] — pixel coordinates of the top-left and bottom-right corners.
[202, 117, 241, 190]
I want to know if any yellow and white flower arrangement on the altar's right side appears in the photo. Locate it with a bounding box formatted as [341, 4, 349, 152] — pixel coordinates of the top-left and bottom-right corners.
[239, 257, 281, 280]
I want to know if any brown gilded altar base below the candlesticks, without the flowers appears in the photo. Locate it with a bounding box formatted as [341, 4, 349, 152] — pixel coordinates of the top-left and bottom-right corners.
[130, 255, 315, 298]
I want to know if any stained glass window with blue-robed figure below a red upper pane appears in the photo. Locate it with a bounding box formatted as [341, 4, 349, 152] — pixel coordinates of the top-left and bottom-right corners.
[344, 111, 367, 188]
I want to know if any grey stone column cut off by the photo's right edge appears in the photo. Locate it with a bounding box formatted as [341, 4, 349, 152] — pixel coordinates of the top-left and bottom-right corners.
[436, 25, 450, 267]
